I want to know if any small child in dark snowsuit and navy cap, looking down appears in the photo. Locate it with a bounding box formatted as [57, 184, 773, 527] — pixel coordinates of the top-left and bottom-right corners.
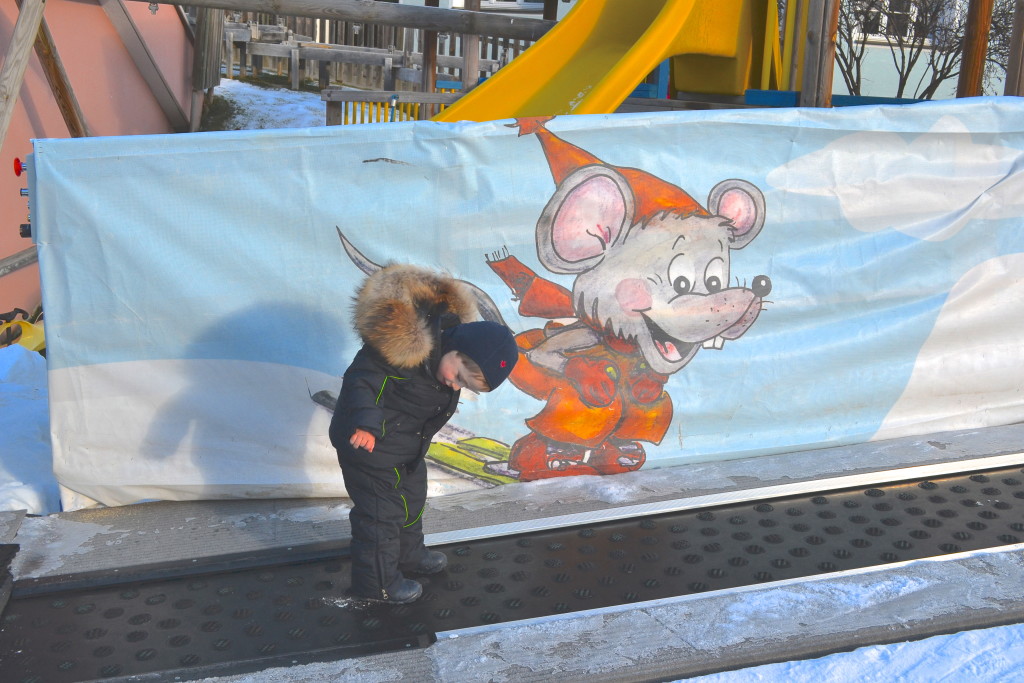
[331, 265, 518, 604]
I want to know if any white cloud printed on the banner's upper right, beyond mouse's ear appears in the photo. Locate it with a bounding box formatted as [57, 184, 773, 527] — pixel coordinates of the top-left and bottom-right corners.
[767, 116, 1024, 242]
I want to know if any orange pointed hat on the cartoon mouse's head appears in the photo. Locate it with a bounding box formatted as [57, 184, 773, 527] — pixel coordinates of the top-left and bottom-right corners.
[515, 116, 710, 223]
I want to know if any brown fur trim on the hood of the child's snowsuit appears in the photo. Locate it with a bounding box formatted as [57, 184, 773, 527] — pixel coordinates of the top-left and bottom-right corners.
[353, 264, 478, 368]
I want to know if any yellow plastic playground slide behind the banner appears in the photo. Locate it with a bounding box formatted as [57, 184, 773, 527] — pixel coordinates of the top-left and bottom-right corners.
[433, 0, 777, 121]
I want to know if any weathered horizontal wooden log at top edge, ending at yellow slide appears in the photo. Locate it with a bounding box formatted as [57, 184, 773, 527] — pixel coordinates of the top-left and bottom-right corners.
[133, 0, 555, 40]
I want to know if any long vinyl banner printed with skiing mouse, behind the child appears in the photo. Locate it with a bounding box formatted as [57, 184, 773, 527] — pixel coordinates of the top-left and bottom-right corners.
[32, 98, 1024, 507]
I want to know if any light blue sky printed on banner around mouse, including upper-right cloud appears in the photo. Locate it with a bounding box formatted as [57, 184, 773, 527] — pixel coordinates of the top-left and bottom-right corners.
[33, 98, 1024, 457]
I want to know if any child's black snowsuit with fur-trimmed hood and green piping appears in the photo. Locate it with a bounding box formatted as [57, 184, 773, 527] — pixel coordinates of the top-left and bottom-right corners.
[330, 266, 475, 599]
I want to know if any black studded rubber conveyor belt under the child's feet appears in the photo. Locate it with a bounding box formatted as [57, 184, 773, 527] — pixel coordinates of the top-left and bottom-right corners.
[0, 468, 1024, 683]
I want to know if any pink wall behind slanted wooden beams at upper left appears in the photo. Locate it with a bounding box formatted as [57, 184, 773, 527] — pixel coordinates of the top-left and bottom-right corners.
[0, 0, 191, 312]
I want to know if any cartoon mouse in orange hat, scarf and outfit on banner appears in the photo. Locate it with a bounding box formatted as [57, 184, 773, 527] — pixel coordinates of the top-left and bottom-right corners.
[488, 117, 771, 480]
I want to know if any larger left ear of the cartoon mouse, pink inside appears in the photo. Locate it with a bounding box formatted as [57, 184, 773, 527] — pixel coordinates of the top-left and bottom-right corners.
[537, 165, 635, 273]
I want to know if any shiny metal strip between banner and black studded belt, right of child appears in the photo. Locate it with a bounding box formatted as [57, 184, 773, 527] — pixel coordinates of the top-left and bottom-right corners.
[425, 452, 1024, 546]
